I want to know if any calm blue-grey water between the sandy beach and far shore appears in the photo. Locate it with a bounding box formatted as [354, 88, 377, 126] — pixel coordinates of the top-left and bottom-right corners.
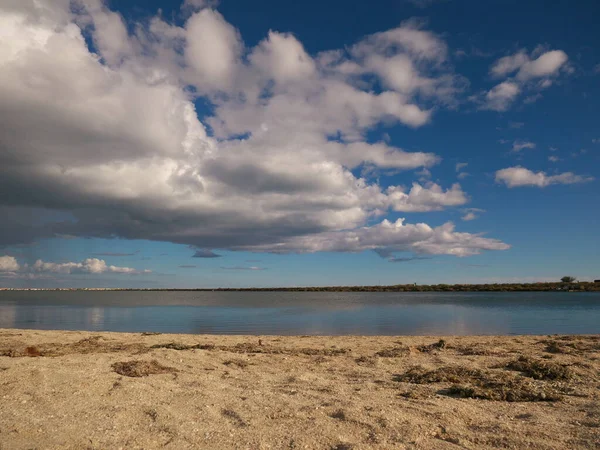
[0, 291, 600, 335]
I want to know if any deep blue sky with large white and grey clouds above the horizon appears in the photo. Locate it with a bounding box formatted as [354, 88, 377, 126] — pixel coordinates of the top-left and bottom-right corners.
[0, 0, 600, 288]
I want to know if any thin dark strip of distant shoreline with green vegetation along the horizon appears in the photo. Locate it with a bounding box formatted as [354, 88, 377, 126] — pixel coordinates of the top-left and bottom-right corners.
[0, 282, 600, 292]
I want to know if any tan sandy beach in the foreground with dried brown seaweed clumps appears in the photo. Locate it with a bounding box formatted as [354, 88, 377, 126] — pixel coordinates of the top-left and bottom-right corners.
[0, 329, 600, 450]
